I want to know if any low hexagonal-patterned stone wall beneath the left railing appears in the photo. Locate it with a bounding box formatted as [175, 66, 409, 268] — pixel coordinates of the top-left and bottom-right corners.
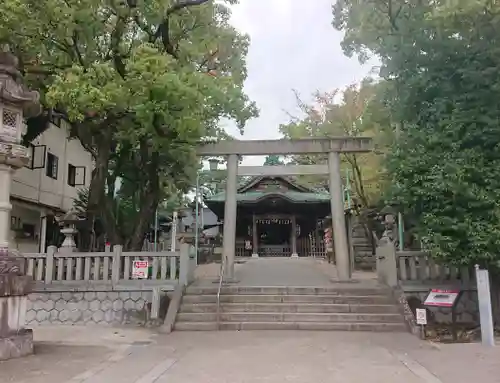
[26, 290, 158, 326]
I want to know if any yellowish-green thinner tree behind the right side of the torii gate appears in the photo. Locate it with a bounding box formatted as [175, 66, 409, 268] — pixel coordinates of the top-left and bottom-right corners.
[280, 79, 392, 207]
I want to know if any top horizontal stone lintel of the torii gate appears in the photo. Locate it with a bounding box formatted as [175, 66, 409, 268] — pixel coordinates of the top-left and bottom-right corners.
[197, 137, 373, 157]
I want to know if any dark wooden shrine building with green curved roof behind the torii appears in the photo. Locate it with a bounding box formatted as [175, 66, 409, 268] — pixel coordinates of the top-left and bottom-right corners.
[204, 176, 330, 257]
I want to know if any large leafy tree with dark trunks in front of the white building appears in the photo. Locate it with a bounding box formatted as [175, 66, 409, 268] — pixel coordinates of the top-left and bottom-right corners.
[0, 0, 256, 249]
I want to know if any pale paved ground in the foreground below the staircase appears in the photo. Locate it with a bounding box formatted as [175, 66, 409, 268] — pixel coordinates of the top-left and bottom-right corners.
[0, 326, 500, 383]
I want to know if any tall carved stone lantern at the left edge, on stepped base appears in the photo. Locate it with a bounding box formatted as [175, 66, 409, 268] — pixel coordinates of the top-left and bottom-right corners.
[0, 47, 40, 360]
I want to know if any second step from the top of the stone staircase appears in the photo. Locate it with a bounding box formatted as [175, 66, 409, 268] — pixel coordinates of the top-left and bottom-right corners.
[182, 294, 394, 305]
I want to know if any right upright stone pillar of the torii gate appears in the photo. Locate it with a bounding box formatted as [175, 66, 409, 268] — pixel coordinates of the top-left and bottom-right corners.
[328, 152, 351, 281]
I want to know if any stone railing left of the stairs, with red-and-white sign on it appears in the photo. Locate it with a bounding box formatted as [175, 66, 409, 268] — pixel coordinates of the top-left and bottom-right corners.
[23, 244, 195, 285]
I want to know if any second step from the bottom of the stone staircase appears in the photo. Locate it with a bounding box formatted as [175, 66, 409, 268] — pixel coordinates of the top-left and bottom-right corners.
[177, 312, 402, 323]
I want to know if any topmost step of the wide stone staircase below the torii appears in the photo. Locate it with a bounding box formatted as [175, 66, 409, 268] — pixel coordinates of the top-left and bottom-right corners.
[185, 285, 389, 296]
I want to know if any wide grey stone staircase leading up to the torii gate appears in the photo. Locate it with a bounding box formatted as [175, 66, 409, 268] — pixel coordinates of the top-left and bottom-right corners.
[174, 286, 406, 331]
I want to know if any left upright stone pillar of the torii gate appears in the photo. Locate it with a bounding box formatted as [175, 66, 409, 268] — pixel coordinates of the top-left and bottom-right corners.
[222, 154, 238, 281]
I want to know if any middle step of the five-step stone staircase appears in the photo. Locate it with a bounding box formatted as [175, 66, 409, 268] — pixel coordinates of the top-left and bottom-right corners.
[180, 303, 398, 314]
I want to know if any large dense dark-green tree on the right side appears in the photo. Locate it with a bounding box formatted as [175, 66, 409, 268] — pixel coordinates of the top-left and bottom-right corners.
[334, 0, 500, 265]
